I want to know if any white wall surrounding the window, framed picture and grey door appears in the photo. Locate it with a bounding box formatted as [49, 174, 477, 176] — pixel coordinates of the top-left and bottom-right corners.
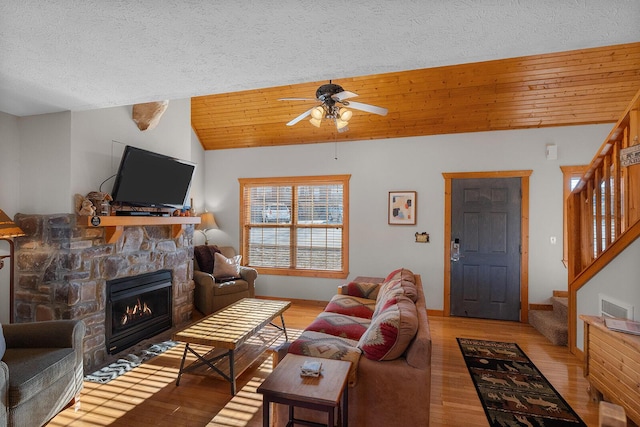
[205, 124, 611, 309]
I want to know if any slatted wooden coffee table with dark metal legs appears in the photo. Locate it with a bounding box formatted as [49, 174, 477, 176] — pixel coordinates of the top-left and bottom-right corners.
[173, 298, 291, 395]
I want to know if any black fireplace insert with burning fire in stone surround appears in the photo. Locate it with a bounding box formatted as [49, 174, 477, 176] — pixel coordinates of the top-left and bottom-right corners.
[105, 270, 172, 354]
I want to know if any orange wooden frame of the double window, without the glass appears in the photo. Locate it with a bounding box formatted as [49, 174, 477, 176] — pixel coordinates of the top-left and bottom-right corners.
[238, 174, 351, 279]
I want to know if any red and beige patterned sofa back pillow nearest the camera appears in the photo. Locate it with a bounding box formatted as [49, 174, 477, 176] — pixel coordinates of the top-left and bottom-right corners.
[358, 295, 418, 360]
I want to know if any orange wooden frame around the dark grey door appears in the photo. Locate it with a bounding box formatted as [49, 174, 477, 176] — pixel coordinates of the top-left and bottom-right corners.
[442, 170, 533, 323]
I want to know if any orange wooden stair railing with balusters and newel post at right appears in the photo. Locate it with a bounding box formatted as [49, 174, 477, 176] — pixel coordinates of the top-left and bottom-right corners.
[566, 90, 640, 355]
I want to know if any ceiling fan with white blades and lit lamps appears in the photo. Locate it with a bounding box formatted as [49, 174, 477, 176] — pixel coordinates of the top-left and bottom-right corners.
[279, 80, 387, 132]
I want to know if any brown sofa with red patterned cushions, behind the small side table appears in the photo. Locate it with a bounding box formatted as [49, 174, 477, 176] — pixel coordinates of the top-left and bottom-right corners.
[274, 269, 431, 427]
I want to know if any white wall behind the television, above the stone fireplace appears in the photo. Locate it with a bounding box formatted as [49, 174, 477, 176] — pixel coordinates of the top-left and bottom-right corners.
[7, 99, 198, 214]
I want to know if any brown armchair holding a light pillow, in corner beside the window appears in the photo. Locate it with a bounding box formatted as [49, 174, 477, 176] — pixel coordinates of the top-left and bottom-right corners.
[193, 245, 258, 315]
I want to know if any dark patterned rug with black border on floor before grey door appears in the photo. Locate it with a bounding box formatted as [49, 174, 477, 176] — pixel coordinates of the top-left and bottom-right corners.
[458, 338, 586, 427]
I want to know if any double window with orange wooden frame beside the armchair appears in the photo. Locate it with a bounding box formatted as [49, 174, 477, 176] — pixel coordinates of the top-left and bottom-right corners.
[239, 175, 351, 278]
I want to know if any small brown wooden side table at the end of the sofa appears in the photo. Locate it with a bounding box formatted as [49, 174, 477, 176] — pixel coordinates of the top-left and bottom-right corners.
[258, 354, 351, 427]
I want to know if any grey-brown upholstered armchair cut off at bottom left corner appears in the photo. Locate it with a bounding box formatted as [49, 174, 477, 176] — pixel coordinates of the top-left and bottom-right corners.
[0, 320, 86, 427]
